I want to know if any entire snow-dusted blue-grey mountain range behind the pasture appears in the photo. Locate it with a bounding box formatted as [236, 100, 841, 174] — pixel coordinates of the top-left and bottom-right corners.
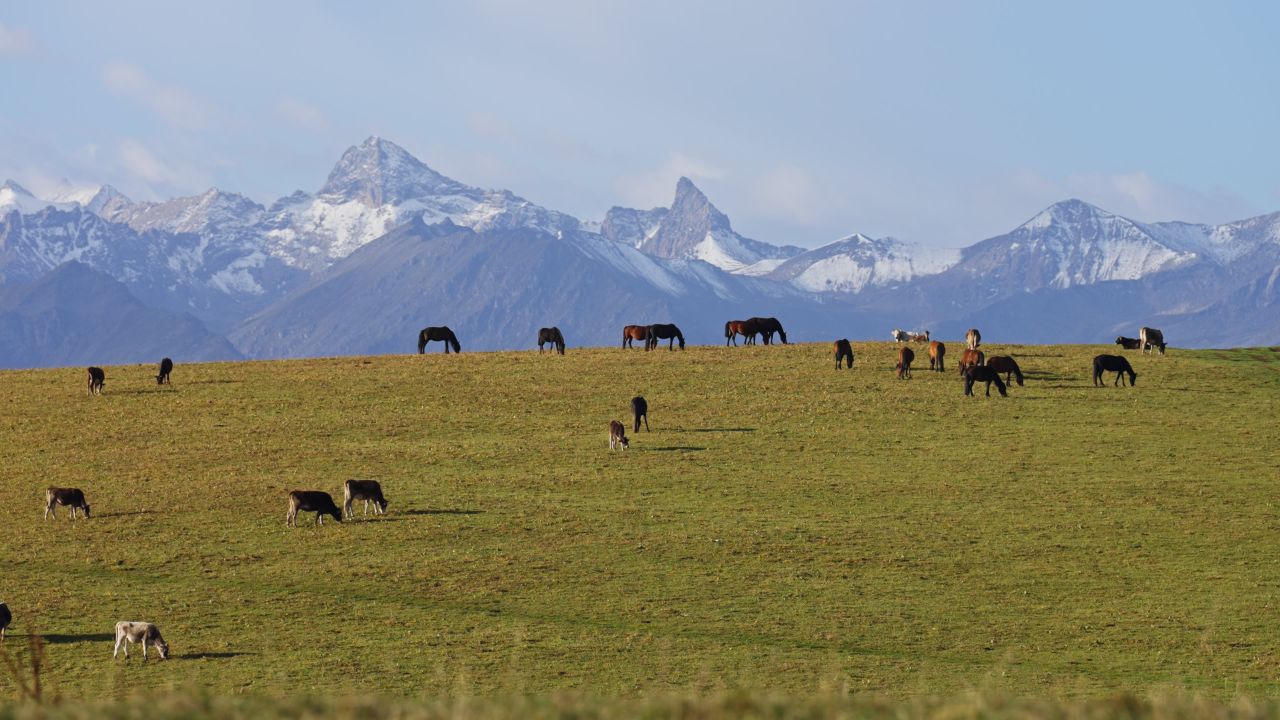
[0, 137, 1280, 363]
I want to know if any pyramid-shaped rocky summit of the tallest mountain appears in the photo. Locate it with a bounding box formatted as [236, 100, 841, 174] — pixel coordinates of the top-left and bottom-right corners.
[320, 136, 467, 208]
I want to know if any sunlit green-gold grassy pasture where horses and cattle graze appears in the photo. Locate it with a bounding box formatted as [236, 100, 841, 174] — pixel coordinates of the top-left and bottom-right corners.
[0, 343, 1280, 700]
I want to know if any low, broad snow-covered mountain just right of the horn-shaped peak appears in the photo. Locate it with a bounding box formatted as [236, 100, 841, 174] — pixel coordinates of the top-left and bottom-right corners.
[764, 233, 960, 293]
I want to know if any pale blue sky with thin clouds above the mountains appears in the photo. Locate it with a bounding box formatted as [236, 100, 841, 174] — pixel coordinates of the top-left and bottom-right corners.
[0, 0, 1280, 246]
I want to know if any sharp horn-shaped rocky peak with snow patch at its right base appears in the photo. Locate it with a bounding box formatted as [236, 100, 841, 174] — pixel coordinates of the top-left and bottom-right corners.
[600, 178, 804, 274]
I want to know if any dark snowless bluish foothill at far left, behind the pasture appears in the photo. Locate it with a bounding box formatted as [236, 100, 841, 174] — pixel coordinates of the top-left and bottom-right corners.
[0, 263, 242, 368]
